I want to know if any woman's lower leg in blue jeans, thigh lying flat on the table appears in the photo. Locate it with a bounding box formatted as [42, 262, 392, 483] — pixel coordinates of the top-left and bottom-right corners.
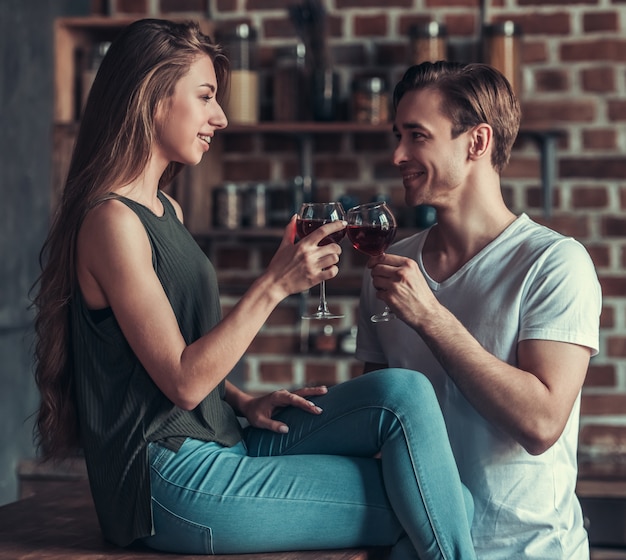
[144, 440, 408, 560]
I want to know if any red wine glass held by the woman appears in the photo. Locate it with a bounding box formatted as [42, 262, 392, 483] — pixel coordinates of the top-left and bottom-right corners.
[296, 202, 346, 319]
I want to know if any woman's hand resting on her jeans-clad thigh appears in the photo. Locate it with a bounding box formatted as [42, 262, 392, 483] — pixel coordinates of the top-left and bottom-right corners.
[240, 386, 328, 434]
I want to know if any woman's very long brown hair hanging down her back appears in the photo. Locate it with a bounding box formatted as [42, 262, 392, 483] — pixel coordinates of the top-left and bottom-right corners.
[34, 19, 228, 458]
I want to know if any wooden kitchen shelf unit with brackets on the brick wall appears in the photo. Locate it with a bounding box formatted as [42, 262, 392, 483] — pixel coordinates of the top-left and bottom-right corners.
[52, 16, 561, 234]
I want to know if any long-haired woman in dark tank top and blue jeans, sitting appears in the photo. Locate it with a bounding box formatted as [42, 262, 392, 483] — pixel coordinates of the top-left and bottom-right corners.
[36, 20, 474, 559]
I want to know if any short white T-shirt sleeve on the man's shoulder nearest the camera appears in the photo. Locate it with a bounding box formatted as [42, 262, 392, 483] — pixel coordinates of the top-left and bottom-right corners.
[519, 238, 602, 356]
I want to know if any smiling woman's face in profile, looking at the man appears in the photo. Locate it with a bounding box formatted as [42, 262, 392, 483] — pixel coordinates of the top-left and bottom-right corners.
[152, 55, 228, 165]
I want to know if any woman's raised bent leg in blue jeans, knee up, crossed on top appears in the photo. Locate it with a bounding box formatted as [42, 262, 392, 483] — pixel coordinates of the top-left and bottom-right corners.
[246, 369, 475, 560]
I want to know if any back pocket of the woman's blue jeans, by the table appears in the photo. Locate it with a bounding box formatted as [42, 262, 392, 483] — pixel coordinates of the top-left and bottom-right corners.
[143, 499, 215, 554]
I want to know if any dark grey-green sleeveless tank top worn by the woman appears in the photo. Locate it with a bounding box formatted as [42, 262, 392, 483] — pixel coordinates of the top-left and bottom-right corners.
[71, 192, 241, 546]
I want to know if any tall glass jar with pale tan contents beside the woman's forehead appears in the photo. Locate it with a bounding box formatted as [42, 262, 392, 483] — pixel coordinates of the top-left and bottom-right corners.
[219, 23, 260, 124]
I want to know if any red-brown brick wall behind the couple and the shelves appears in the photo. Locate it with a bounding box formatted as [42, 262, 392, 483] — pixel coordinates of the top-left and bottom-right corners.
[105, 0, 626, 460]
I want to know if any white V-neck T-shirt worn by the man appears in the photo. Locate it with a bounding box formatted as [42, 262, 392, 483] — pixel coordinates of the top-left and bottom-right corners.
[356, 214, 601, 560]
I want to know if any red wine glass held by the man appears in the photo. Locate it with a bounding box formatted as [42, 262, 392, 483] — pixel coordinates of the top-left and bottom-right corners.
[346, 202, 397, 323]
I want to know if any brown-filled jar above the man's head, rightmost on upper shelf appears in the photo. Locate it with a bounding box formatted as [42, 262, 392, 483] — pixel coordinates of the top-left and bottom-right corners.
[483, 21, 522, 95]
